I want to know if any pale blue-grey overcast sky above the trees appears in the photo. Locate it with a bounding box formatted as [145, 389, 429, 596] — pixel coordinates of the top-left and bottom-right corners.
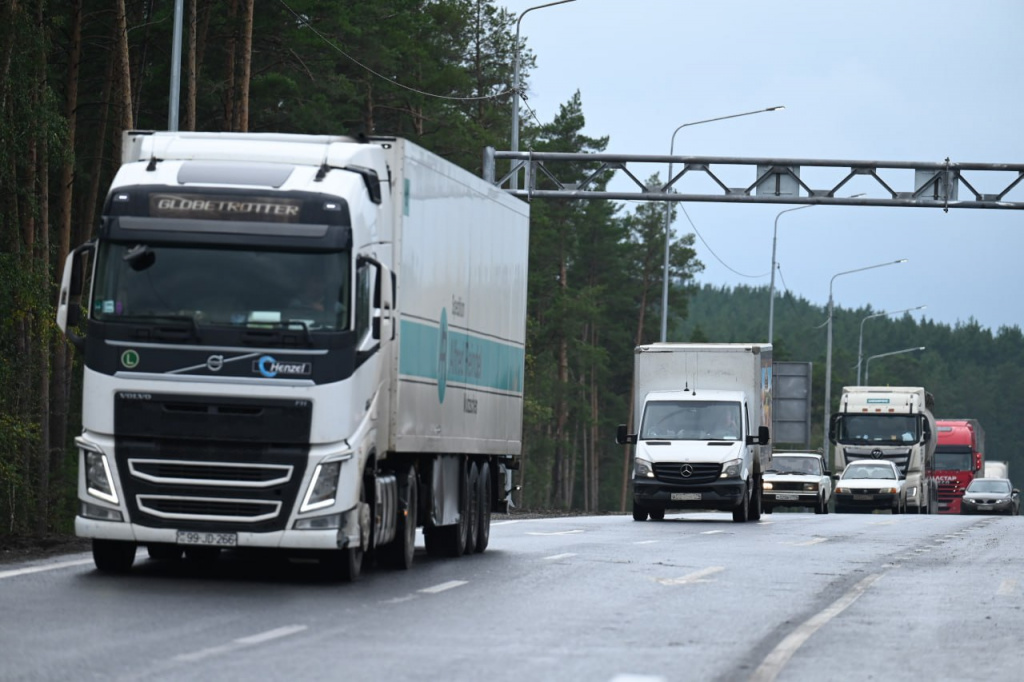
[500, 0, 1024, 336]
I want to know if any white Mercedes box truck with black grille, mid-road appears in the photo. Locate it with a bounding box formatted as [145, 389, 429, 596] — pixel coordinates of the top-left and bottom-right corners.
[615, 343, 772, 521]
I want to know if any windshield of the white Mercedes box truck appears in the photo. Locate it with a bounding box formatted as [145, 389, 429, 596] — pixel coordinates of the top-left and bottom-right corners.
[640, 400, 742, 440]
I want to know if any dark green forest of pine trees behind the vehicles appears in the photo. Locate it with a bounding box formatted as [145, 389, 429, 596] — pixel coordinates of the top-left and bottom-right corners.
[0, 0, 1024, 536]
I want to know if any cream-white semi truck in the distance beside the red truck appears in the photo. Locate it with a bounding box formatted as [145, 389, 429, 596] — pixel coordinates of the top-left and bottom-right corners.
[828, 386, 939, 514]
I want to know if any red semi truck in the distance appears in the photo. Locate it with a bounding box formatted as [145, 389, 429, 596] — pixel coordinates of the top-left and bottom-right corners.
[935, 419, 985, 514]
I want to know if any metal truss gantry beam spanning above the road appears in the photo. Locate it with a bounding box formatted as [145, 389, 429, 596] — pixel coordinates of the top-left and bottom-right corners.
[483, 147, 1024, 211]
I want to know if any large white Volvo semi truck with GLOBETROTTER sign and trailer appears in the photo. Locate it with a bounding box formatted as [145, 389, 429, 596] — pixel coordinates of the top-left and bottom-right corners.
[57, 131, 529, 580]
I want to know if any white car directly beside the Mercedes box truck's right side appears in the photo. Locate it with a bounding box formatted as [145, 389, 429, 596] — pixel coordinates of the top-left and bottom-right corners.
[762, 453, 831, 514]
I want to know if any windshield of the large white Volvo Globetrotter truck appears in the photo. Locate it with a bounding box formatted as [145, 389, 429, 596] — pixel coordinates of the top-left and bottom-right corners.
[91, 242, 350, 331]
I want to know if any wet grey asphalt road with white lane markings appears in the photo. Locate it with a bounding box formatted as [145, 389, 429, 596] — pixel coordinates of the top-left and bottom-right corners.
[0, 512, 1024, 682]
